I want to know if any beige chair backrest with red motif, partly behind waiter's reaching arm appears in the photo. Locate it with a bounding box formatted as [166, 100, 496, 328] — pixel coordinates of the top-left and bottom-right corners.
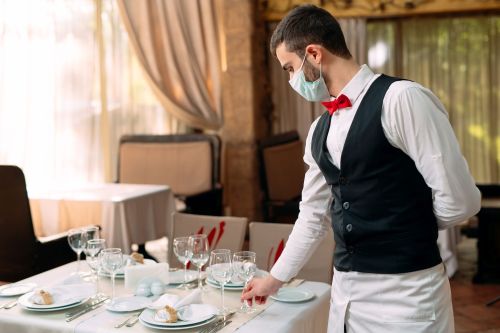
[249, 222, 335, 283]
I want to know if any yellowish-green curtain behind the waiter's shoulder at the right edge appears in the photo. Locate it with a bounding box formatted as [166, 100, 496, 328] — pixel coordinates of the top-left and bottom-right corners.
[402, 15, 500, 183]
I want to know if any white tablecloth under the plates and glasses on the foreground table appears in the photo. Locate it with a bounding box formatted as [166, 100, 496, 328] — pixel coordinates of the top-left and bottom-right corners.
[0, 263, 330, 333]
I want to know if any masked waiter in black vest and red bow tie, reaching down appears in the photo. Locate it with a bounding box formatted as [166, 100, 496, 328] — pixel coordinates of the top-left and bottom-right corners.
[241, 5, 481, 333]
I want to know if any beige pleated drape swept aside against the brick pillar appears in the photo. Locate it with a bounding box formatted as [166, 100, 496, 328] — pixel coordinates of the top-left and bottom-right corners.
[118, 0, 222, 130]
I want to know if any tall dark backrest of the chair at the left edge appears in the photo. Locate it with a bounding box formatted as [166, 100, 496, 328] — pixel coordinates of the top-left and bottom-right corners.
[0, 165, 37, 281]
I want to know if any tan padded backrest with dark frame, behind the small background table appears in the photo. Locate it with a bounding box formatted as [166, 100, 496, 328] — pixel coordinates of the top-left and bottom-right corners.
[118, 134, 220, 196]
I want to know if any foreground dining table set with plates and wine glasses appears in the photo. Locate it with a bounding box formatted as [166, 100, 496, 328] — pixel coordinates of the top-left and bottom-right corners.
[0, 262, 330, 333]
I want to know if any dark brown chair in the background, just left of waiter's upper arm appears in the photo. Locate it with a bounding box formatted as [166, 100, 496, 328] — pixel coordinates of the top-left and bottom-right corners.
[259, 131, 305, 223]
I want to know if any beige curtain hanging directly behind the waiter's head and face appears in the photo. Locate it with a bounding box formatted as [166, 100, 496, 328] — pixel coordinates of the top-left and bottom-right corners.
[270, 19, 366, 142]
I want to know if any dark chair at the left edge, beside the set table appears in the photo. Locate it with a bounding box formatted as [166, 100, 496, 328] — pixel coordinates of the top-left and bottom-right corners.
[0, 165, 75, 282]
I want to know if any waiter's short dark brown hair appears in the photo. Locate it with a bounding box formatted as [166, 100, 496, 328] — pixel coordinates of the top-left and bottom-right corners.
[270, 5, 352, 59]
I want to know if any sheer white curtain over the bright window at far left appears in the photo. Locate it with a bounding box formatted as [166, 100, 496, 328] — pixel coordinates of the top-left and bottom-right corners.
[0, 0, 179, 186]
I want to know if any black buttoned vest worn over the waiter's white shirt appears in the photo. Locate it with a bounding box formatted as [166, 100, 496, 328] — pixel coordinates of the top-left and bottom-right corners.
[311, 75, 441, 274]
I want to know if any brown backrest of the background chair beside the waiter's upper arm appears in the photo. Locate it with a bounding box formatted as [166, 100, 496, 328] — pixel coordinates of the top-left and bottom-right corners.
[259, 131, 305, 201]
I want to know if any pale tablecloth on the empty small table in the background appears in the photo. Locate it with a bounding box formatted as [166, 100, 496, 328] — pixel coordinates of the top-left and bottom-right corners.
[28, 184, 175, 253]
